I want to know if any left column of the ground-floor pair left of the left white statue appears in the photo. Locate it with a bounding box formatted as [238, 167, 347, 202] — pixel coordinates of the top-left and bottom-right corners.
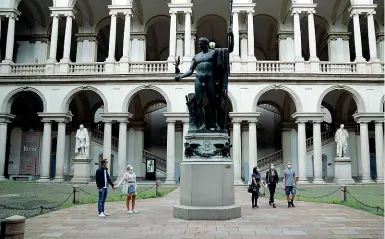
[38, 120, 52, 182]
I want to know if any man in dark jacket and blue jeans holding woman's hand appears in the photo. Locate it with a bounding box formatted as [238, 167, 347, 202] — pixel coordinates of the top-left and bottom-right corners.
[95, 159, 116, 217]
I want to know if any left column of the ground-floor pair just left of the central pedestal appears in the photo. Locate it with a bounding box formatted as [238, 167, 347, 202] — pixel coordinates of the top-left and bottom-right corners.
[165, 120, 175, 184]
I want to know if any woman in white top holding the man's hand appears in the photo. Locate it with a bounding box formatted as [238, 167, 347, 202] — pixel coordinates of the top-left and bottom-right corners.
[117, 165, 138, 214]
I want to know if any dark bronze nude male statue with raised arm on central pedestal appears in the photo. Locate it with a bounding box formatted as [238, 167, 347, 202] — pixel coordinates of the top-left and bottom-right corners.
[175, 27, 234, 132]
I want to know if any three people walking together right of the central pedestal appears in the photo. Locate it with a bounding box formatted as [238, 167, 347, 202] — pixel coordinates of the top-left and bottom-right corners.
[251, 162, 296, 208]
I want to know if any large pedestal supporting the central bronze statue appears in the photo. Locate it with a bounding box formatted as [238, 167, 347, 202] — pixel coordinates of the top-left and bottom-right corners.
[174, 132, 241, 220]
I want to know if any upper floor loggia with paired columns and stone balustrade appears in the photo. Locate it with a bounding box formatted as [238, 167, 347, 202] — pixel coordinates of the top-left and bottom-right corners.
[0, 0, 384, 75]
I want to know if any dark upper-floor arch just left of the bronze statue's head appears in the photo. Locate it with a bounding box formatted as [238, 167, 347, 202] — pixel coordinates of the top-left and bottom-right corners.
[146, 16, 170, 61]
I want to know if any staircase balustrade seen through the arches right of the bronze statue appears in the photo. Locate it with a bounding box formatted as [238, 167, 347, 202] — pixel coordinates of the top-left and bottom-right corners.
[258, 130, 334, 172]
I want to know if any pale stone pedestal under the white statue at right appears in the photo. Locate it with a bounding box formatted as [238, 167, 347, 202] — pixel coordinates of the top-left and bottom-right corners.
[333, 157, 354, 184]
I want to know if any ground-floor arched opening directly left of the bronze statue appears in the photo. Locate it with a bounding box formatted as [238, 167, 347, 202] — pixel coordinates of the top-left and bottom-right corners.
[126, 89, 168, 178]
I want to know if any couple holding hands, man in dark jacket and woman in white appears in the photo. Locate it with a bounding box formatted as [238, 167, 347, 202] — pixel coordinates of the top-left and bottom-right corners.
[95, 159, 138, 217]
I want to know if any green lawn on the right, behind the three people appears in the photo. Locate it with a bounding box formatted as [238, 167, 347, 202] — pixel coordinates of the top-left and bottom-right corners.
[262, 184, 384, 216]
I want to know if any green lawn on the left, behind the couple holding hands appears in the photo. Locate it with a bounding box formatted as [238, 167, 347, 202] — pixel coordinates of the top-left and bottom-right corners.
[0, 182, 176, 220]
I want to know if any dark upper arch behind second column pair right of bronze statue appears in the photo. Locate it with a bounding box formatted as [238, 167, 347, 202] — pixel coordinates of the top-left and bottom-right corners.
[301, 15, 330, 61]
